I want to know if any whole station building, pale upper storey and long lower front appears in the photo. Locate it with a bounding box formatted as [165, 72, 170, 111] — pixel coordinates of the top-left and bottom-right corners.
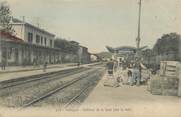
[0, 19, 63, 65]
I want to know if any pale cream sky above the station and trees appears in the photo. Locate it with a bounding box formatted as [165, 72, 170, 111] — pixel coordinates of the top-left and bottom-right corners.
[3, 0, 181, 53]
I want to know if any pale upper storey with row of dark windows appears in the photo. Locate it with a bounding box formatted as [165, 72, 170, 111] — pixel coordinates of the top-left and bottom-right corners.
[11, 18, 55, 48]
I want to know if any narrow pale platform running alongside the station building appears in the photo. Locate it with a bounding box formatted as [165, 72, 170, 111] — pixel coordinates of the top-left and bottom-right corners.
[0, 63, 99, 82]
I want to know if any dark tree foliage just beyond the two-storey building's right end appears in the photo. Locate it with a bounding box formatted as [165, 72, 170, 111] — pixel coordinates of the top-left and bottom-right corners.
[55, 38, 79, 54]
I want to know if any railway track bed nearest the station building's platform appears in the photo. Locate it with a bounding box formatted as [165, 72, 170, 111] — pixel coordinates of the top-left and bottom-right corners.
[0, 67, 104, 108]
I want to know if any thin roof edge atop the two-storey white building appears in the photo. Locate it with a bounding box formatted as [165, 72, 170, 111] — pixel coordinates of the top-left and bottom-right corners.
[11, 18, 55, 36]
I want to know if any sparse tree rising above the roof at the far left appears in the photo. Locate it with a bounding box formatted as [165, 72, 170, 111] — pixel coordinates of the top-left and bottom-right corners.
[0, 2, 13, 33]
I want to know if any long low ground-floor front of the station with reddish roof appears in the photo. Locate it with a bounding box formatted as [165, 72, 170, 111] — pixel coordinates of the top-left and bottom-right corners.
[0, 33, 63, 66]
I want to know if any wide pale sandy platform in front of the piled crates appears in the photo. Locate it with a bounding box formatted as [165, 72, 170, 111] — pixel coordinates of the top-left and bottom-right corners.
[81, 70, 181, 117]
